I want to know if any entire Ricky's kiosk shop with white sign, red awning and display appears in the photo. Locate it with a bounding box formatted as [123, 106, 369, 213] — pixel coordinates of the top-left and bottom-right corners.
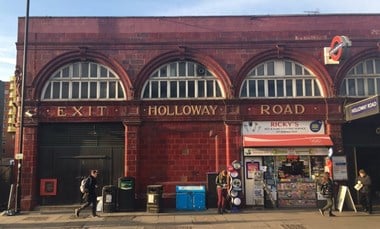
[242, 121, 332, 208]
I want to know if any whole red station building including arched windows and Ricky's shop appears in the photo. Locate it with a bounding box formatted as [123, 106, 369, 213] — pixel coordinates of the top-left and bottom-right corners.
[15, 14, 380, 209]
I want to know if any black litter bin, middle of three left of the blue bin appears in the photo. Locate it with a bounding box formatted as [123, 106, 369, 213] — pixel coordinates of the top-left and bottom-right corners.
[117, 177, 135, 211]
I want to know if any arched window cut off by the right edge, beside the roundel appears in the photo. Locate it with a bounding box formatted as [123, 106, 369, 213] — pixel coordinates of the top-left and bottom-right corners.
[339, 58, 380, 97]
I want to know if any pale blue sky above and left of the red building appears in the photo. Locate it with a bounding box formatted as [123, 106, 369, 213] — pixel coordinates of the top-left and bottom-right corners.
[0, 0, 380, 81]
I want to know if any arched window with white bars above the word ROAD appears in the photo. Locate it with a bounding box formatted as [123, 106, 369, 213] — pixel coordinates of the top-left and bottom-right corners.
[240, 60, 323, 98]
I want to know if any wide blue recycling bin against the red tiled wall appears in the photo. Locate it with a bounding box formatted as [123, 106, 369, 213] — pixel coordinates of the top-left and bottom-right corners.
[176, 185, 206, 211]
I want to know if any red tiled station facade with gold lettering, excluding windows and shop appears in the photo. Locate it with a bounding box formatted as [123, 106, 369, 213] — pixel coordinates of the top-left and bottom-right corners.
[15, 15, 380, 209]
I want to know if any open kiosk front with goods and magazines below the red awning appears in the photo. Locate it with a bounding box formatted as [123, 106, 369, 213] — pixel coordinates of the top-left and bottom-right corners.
[244, 148, 328, 207]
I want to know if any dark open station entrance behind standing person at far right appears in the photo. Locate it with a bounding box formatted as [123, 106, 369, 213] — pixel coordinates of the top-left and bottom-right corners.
[356, 147, 380, 204]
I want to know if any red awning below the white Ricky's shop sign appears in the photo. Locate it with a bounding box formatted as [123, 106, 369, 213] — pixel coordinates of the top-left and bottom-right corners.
[243, 134, 333, 147]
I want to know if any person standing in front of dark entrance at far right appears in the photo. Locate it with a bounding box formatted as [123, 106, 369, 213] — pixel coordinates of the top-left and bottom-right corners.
[356, 169, 372, 214]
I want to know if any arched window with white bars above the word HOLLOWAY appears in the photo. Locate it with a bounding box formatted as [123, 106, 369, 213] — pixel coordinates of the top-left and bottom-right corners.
[141, 61, 224, 100]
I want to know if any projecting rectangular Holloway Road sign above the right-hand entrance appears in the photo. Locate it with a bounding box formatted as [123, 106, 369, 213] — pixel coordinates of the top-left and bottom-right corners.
[344, 95, 379, 121]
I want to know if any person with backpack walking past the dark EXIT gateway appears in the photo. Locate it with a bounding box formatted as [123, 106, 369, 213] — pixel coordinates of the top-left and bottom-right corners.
[74, 170, 99, 217]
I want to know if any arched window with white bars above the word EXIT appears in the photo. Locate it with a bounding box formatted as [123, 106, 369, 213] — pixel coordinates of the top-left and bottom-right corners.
[41, 62, 125, 101]
